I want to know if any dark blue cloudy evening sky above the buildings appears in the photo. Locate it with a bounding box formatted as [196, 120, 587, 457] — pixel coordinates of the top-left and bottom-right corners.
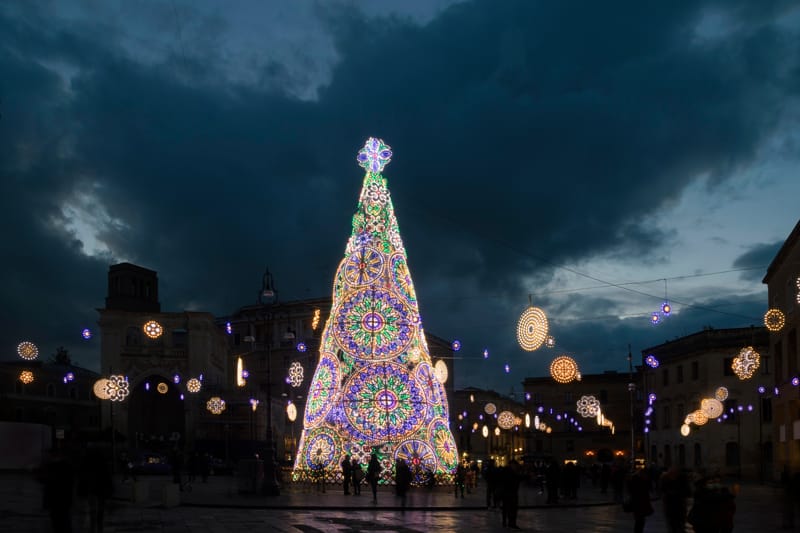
[0, 0, 800, 392]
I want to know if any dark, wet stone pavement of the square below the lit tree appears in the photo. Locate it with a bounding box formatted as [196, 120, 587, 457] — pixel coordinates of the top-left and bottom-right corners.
[0, 476, 800, 533]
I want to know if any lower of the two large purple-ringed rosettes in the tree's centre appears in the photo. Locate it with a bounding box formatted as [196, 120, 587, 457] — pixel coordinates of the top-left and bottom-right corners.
[342, 363, 426, 444]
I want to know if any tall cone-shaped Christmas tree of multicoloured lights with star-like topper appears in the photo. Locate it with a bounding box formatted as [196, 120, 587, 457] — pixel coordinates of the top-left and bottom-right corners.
[293, 138, 458, 482]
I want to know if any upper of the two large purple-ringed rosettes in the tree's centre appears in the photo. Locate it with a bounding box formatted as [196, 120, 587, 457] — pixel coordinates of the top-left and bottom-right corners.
[333, 289, 417, 361]
